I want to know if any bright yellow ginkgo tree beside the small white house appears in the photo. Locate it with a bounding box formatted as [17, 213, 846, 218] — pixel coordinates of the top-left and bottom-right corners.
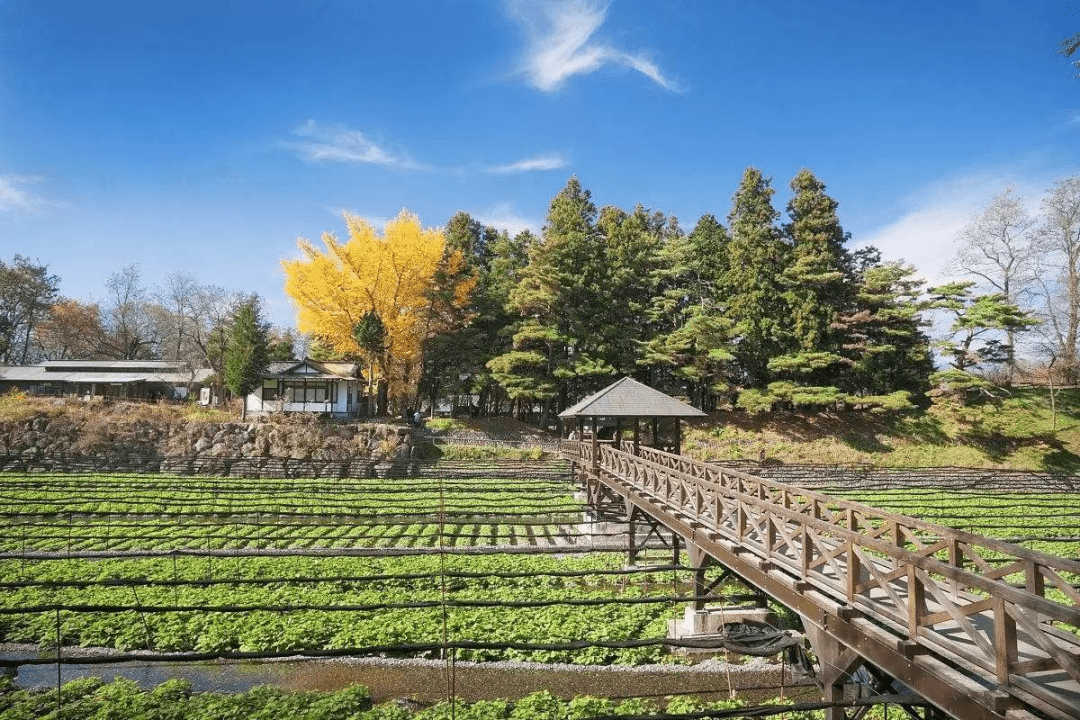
[282, 210, 476, 415]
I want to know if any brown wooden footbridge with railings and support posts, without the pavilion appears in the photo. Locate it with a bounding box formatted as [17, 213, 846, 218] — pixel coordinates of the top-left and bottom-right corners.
[561, 440, 1080, 720]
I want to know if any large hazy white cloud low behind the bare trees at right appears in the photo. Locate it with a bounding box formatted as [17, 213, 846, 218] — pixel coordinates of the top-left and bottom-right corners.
[855, 169, 1047, 285]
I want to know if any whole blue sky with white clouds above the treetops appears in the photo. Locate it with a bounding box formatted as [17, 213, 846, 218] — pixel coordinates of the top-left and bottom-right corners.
[0, 0, 1080, 324]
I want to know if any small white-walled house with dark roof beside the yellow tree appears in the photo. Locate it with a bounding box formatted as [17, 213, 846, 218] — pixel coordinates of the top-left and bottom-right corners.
[247, 358, 367, 418]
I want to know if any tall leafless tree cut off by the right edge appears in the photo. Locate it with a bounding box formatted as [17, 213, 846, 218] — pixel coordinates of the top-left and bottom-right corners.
[1032, 176, 1080, 383]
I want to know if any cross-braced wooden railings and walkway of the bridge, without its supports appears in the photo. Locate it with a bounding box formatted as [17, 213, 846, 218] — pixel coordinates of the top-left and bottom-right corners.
[566, 443, 1080, 717]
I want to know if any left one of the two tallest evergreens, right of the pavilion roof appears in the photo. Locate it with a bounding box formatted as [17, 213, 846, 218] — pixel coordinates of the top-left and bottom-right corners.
[720, 167, 789, 388]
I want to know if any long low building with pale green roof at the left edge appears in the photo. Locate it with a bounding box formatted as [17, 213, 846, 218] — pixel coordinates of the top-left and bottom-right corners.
[0, 361, 212, 399]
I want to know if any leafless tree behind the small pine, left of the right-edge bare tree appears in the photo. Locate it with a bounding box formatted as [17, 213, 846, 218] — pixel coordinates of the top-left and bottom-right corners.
[954, 188, 1037, 380]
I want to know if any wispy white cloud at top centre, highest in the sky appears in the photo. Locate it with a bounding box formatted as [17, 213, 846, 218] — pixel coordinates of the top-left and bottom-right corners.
[511, 0, 678, 93]
